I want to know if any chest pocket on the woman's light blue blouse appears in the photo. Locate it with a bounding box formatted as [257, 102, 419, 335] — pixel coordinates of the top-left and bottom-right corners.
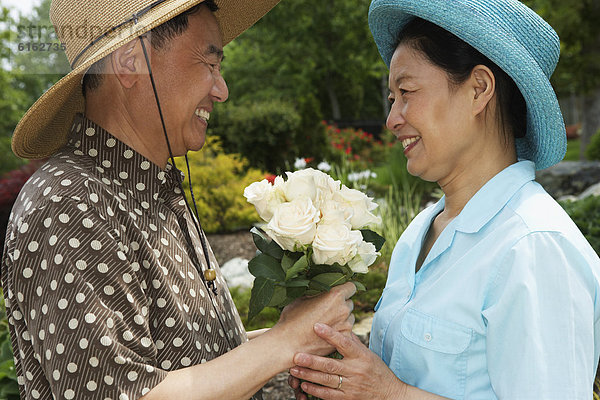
[390, 308, 473, 399]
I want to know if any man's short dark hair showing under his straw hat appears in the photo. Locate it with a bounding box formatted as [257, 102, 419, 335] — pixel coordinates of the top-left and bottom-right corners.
[82, 0, 219, 97]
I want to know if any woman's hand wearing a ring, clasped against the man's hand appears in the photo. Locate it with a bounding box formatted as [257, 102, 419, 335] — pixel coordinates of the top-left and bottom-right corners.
[288, 324, 407, 400]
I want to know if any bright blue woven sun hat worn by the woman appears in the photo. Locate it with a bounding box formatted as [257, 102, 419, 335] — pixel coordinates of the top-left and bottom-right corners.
[369, 0, 567, 170]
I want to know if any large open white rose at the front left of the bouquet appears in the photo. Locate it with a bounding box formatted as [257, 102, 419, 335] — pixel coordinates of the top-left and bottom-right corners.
[265, 197, 319, 251]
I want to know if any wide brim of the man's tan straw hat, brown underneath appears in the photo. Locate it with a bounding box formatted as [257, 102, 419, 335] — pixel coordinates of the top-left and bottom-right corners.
[12, 0, 279, 159]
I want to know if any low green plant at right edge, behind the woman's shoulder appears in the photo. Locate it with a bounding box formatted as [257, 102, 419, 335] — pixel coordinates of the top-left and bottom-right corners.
[561, 196, 600, 254]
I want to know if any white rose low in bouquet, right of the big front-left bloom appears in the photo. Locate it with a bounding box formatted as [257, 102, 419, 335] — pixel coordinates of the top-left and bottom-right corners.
[312, 224, 362, 265]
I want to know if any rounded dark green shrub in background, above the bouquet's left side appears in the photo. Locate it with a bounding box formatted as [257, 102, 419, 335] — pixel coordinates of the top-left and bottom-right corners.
[210, 100, 325, 173]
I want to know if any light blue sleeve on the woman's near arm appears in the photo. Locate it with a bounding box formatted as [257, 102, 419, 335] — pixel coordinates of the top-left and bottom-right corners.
[483, 232, 596, 399]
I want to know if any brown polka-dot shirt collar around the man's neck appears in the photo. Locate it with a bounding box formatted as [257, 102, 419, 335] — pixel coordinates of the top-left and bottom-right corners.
[67, 114, 183, 208]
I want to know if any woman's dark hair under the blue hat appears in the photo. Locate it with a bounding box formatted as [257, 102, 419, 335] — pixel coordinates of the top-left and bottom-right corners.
[395, 18, 527, 142]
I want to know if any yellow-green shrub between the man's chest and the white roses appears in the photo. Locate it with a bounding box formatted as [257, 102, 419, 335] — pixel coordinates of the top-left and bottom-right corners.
[177, 138, 265, 233]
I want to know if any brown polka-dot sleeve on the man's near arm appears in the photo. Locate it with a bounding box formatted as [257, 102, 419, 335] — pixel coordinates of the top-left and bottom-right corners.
[10, 198, 167, 400]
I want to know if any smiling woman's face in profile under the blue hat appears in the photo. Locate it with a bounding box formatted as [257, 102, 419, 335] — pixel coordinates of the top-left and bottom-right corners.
[387, 44, 484, 185]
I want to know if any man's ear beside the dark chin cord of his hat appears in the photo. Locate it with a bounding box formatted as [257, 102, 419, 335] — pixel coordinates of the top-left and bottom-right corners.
[111, 39, 148, 89]
